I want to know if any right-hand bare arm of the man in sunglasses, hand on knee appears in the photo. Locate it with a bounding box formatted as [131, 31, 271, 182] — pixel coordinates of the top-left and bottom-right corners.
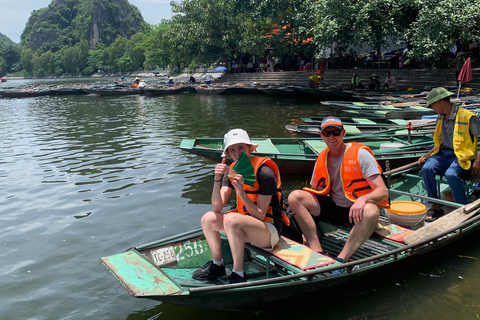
[349, 174, 388, 223]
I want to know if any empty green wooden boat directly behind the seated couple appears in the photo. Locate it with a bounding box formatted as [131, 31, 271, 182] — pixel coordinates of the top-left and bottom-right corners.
[180, 133, 433, 174]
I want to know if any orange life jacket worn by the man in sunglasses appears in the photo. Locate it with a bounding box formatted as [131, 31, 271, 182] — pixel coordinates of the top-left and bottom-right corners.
[303, 142, 390, 208]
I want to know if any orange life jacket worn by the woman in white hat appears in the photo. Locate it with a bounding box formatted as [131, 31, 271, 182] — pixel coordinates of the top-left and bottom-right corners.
[230, 157, 290, 226]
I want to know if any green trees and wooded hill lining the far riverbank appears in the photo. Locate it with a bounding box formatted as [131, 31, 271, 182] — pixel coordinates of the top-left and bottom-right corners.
[0, 0, 480, 75]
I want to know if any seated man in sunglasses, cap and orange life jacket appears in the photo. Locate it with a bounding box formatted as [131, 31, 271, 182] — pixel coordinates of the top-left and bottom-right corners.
[288, 116, 388, 262]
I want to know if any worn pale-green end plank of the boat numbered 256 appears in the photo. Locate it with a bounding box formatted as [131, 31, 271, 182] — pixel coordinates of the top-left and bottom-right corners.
[100, 251, 183, 297]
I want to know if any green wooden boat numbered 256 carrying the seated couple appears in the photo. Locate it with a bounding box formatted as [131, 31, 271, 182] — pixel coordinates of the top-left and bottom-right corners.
[100, 165, 480, 311]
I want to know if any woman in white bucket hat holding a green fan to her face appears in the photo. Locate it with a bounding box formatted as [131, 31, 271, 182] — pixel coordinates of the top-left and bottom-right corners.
[192, 129, 282, 283]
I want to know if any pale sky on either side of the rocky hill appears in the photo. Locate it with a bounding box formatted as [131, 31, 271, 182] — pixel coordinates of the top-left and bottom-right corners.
[0, 0, 172, 43]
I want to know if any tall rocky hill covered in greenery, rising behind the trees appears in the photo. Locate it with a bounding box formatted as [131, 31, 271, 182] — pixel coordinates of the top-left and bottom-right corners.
[21, 0, 144, 52]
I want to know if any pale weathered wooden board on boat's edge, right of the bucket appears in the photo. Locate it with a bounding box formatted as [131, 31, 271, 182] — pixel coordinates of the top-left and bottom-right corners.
[403, 199, 480, 244]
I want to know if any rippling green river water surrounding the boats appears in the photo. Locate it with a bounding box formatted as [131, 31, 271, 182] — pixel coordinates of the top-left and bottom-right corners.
[0, 80, 480, 320]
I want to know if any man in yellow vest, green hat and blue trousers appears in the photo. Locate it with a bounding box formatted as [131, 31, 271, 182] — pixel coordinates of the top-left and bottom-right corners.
[418, 87, 480, 222]
